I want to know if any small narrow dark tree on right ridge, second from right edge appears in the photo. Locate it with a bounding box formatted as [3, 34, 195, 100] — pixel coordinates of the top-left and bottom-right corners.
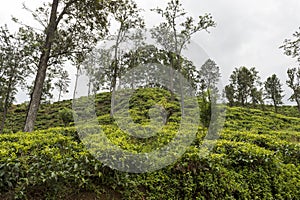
[265, 74, 284, 112]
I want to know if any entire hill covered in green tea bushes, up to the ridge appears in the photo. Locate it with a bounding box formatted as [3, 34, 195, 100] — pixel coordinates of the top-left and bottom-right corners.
[0, 89, 300, 199]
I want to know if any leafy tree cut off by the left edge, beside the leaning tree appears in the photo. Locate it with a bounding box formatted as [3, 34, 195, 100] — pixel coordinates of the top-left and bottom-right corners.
[0, 26, 31, 133]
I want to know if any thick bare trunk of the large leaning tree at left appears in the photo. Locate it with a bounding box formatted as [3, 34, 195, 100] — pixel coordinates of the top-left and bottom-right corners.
[24, 0, 59, 132]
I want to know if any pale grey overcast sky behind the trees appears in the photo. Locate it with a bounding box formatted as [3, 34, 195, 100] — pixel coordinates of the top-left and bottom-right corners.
[0, 0, 300, 102]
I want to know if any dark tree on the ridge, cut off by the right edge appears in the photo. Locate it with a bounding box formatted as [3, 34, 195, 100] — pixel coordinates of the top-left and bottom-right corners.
[286, 67, 300, 112]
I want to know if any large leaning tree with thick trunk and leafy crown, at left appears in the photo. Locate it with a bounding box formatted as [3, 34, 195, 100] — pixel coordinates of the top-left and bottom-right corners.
[19, 0, 110, 132]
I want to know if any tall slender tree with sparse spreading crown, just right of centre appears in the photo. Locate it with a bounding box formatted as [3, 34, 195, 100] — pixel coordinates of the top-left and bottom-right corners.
[151, 0, 216, 114]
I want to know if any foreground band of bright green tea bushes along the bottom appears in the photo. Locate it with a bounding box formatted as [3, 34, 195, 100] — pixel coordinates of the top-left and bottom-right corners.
[0, 125, 300, 199]
